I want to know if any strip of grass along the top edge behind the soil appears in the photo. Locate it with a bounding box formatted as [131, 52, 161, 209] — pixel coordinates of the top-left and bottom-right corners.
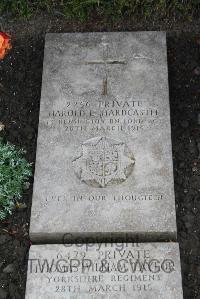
[0, 0, 200, 21]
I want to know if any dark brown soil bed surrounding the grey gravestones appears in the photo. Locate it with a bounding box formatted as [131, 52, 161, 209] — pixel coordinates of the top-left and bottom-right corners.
[0, 17, 200, 299]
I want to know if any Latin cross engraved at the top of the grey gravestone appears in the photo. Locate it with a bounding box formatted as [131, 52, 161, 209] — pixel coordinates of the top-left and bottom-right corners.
[84, 43, 126, 96]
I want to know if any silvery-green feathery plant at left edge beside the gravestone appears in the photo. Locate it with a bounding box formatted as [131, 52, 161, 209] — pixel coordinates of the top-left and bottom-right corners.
[0, 140, 32, 220]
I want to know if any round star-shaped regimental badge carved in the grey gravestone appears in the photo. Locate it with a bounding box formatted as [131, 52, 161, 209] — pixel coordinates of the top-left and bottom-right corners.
[73, 137, 135, 188]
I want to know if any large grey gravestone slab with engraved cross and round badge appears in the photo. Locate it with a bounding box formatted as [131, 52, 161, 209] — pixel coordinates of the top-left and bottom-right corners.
[30, 32, 176, 243]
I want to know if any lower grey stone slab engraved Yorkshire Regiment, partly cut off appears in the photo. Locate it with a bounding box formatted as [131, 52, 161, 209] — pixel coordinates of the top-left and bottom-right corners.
[26, 243, 183, 299]
